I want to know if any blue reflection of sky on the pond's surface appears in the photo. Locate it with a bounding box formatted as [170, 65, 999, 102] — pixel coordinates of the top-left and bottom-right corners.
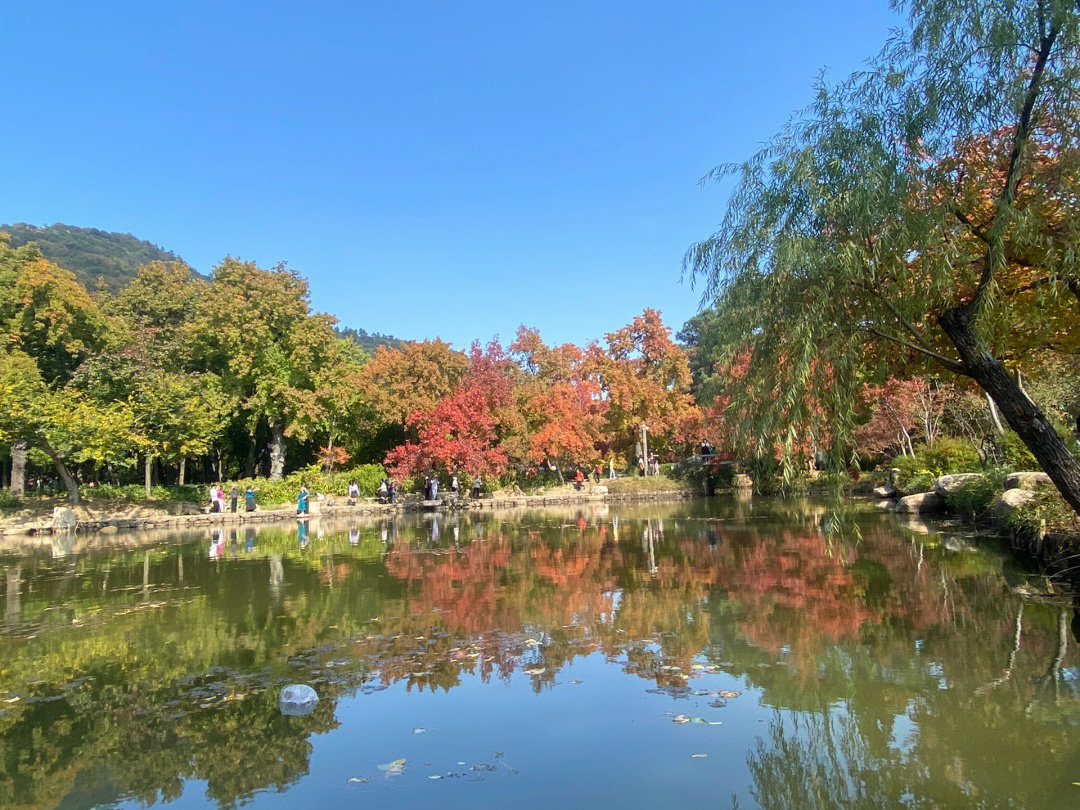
[121, 653, 773, 810]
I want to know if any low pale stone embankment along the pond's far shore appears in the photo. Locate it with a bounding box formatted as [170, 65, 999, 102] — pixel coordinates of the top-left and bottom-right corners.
[0, 485, 700, 536]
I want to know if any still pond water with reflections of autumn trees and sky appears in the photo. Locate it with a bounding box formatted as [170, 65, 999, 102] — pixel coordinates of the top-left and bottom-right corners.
[0, 499, 1080, 810]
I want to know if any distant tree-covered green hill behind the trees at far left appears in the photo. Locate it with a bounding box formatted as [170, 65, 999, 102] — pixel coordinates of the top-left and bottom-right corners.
[0, 222, 187, 291]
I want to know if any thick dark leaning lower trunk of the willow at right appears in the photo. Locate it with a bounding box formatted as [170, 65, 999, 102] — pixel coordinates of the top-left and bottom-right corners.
[939, 307, 1080, 514]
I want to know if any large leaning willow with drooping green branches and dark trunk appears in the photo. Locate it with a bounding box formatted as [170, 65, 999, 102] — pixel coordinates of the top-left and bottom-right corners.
[686, 0, 1080, 512]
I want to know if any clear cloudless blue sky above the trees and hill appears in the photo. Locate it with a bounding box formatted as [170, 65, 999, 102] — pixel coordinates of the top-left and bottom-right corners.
[0, 0, 901, 347]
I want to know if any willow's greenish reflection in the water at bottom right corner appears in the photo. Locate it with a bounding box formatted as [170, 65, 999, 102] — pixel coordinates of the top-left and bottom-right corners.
[747, 606, 1080, 810]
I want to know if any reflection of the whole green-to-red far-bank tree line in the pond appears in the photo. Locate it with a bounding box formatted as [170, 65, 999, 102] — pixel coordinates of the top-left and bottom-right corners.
[0, 503, 1067, 807]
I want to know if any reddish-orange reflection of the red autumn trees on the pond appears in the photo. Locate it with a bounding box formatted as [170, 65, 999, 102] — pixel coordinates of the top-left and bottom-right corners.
[369, 525, 993, 685]
